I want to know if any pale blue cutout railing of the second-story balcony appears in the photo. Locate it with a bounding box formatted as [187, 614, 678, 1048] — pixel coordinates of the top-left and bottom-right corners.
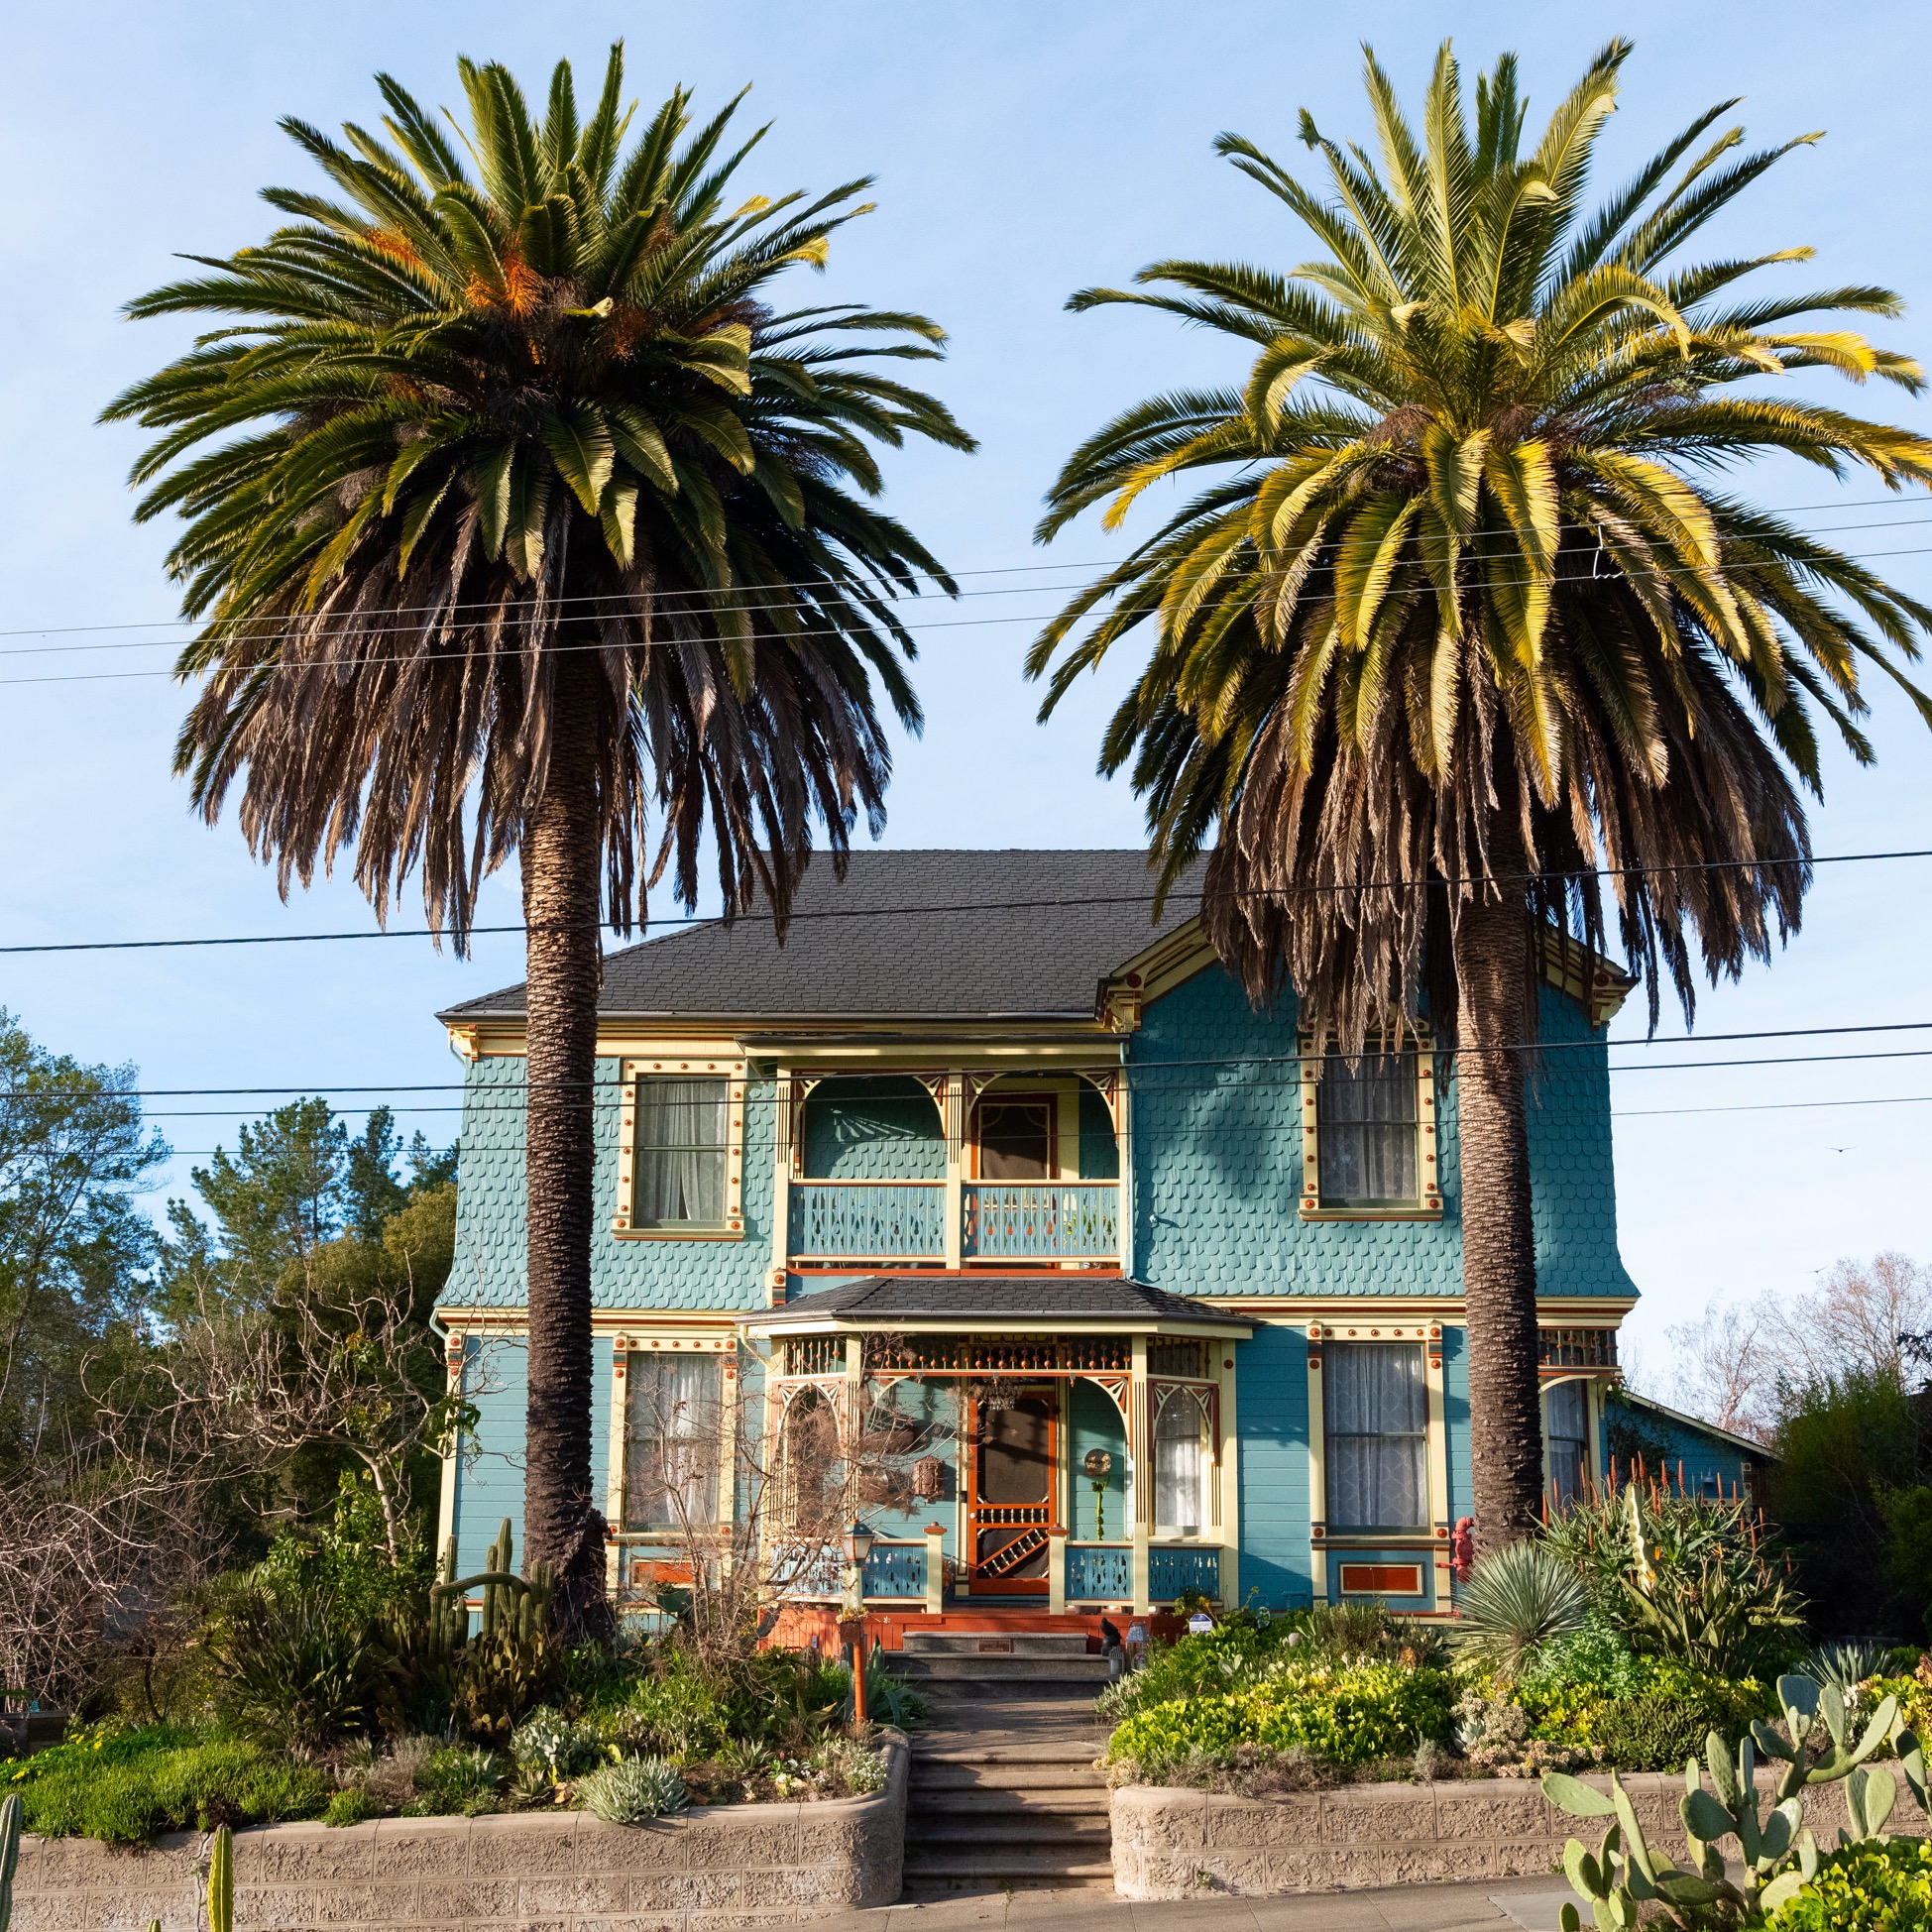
[790, 1181, 1120, 1266]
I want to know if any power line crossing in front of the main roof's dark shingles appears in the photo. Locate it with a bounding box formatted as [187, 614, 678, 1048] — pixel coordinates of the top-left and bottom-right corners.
[0, 847, 1932, 957]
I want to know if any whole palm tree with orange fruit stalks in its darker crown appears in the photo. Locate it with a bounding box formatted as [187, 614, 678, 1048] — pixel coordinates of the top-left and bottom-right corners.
[106, 47, 971, 1629]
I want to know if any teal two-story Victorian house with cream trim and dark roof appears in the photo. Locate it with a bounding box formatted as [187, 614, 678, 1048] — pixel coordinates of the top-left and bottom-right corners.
[438, 852, 1637, 1627]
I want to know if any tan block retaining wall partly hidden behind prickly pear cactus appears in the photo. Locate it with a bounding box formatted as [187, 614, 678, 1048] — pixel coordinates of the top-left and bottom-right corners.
[1113, 1771, 1928, 1899]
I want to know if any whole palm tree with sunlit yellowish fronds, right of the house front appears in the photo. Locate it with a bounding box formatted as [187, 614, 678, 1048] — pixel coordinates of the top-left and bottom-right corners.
[1030, 41, 1932, 1545]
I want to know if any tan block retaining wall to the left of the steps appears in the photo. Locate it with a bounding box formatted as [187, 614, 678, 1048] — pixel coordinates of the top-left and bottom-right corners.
[14, 1735, 906, 1932]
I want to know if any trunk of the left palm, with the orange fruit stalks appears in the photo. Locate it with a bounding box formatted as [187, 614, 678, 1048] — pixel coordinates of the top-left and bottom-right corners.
[521, 663, 611, 1639]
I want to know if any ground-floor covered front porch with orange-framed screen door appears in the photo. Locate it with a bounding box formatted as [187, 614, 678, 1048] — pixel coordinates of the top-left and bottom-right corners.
[743, 1273, 1254, 1629]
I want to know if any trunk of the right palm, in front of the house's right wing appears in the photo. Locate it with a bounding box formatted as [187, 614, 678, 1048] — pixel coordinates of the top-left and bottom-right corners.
[1453, 839, 1543, 1549]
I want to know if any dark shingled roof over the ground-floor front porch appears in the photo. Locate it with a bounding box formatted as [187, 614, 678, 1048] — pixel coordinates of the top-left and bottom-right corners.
[743, 1273, 1256, 1335]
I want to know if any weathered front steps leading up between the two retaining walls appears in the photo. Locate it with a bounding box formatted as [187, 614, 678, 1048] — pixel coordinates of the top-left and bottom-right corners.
[892, 1631, 1113, 1899]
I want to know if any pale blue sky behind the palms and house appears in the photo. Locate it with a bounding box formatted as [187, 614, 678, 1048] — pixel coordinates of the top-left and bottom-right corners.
[0, 0, 1932, 1356]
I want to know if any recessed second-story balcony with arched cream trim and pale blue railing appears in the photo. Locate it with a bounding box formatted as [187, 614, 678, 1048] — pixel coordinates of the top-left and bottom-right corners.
[786, 1077, 1120, 1269]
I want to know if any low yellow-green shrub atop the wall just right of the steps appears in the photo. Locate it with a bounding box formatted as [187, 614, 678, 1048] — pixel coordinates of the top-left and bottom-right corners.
[1107, 1655, 1455, 1773]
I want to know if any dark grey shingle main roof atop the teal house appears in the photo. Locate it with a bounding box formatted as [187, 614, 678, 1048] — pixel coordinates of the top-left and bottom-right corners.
[442, 851, 1193, 1022]
